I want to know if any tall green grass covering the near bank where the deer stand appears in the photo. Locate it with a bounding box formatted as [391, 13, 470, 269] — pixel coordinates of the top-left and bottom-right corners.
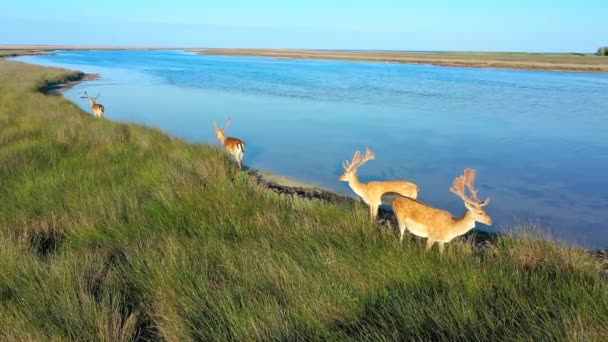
[0, 60, 608, 341]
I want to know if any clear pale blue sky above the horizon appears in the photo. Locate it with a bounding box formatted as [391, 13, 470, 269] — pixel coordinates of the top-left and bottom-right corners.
[0, 0, 608, 52]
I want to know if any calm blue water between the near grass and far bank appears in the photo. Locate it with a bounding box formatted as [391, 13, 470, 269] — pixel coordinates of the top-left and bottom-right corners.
[17, 51, 608, 248]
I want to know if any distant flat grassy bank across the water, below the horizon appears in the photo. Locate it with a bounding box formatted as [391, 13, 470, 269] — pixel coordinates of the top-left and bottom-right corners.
[196, 49, 608, 72]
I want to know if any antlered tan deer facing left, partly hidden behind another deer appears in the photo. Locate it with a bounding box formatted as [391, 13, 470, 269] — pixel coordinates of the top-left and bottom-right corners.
[339, 148, 418, 221]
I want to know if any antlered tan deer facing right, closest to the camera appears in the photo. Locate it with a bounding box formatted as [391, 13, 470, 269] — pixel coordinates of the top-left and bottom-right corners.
[393, 169, 492, 252]
